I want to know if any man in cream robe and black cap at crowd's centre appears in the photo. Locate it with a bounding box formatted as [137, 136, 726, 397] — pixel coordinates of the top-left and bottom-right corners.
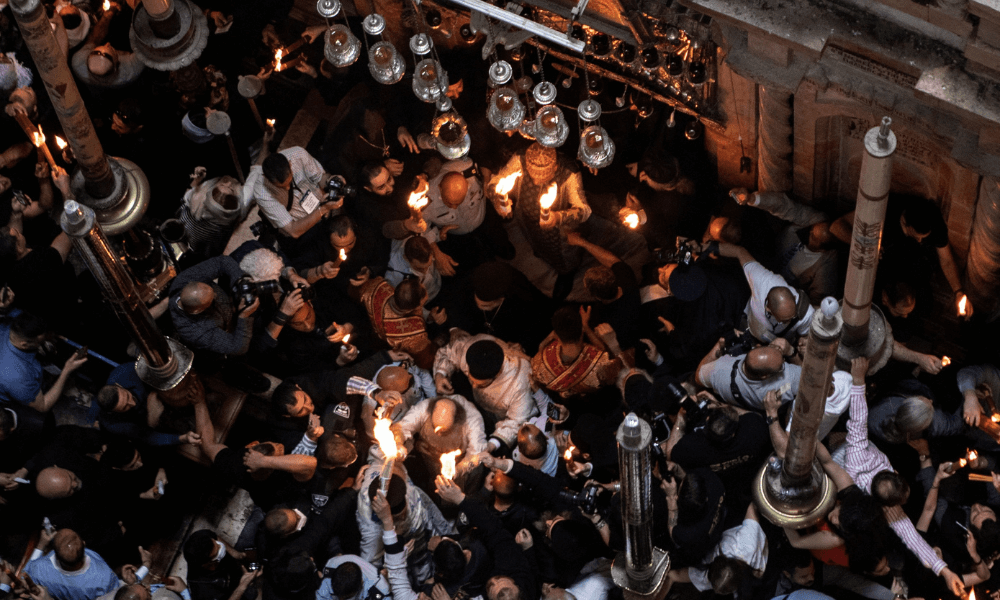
[434, 330, 538, 451]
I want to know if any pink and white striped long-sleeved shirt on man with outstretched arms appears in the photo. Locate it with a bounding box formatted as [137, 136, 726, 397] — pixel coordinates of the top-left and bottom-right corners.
[844, 385, 948, 575]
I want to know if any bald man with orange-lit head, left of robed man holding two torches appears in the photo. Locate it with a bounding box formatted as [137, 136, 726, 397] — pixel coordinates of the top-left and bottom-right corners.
[423, 157, 515, 265]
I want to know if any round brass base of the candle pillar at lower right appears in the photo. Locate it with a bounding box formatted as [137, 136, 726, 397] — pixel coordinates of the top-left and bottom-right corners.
[752, 455, 837, 529]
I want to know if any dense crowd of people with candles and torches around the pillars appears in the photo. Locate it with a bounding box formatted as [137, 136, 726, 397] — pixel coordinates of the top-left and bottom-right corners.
[0, 0, 1000, 600]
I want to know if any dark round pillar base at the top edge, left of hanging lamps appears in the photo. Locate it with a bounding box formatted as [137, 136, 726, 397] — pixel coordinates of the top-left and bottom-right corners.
[128, 0, 208, 71]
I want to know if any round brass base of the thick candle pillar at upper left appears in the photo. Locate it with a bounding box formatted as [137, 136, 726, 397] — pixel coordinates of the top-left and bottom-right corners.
[70, 156, 150, 235]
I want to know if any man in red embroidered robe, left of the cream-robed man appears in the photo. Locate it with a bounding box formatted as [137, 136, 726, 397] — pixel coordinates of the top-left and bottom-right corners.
[351, 273, 437, 369]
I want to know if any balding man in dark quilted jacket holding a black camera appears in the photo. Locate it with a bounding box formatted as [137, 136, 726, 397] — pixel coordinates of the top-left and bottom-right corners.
[170, 256, 260, 356]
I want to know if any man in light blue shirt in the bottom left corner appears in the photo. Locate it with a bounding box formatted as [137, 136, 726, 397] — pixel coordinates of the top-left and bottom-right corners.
[24, 529, 152, 600]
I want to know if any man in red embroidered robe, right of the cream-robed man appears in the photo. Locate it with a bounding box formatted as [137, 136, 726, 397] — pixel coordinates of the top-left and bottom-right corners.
[531, 306, 634, 398]
